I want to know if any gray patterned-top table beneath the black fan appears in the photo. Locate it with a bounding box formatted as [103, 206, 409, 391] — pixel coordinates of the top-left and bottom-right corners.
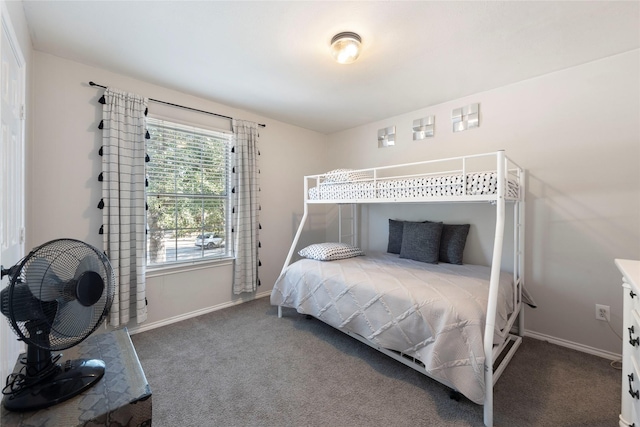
[0, 329, 152, 427]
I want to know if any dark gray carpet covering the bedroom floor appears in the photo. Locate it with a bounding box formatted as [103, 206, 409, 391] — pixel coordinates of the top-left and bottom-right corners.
[132, 298, 621, 427]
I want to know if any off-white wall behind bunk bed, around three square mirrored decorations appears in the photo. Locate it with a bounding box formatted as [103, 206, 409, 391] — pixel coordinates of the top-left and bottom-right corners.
[329, 50, 640, 354]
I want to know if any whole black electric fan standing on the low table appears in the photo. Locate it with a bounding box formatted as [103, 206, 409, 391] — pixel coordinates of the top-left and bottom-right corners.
[0, 239, 115, 412]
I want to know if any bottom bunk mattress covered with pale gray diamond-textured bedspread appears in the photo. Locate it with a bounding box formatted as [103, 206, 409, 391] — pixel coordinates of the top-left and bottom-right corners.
[271, 253, 514, 404]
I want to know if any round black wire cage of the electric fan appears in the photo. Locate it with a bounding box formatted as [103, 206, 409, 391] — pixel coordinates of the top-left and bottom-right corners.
[3, 239, 115, 351]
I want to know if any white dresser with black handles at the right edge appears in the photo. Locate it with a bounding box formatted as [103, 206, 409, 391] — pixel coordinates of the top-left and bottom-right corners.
[615, 259, 640, 427]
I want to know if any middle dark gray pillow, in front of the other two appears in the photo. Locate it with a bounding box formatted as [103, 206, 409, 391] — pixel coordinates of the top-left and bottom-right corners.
[400, 222, 442, 264]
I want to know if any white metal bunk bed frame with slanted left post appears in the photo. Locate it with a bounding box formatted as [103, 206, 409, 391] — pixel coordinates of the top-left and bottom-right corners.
[278, 150, 525, 426]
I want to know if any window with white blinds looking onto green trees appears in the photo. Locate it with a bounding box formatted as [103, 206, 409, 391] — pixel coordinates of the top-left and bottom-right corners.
[147, 118, 231, 266]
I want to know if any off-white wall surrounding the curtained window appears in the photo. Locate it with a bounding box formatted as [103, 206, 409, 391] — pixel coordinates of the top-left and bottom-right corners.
[27, 52, 326, 332]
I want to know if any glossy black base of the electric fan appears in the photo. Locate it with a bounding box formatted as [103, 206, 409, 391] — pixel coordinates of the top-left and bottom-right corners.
[2, 359, 105, 412]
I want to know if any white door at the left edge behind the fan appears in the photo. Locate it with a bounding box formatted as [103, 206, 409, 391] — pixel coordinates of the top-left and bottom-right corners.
[0, 4, 25, 386]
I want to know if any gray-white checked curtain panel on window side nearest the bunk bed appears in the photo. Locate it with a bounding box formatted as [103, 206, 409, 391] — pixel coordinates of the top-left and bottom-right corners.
[231, 120, 261, 295]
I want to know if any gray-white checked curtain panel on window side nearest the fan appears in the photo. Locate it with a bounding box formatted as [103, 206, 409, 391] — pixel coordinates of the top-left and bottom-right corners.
[98, 88, 148, 326]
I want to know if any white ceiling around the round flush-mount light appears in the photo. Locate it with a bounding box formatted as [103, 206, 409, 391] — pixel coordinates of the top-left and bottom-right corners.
[24, 0, 640, 134]
